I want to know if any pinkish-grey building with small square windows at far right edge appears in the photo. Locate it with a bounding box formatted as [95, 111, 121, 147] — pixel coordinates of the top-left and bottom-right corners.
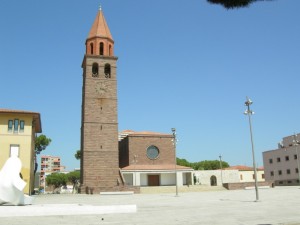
[263, 134, 300, 186]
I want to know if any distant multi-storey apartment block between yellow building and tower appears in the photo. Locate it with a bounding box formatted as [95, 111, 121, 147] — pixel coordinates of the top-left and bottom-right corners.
[40, 155, 65, 187]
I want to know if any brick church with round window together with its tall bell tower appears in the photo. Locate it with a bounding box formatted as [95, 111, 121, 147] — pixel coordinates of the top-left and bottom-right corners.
[80, 8, 192, 193]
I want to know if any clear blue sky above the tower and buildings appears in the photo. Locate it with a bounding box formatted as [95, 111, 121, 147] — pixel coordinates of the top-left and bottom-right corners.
[0, 0, 300, 170]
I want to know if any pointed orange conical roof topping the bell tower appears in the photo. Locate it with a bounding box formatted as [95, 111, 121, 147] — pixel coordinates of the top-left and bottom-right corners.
[88, 7, 113, 40]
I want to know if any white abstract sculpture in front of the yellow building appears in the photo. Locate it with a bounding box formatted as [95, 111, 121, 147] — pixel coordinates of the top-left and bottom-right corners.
[0, 155, 33, 205]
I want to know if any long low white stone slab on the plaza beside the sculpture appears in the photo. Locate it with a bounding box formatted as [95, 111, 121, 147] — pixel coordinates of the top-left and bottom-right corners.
[0, 204, 137, 217]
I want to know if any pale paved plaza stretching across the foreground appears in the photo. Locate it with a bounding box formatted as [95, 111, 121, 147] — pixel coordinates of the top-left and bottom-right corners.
[0, 187, 300, 225]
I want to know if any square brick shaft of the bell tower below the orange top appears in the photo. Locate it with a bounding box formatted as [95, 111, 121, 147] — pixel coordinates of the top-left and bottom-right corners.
[81, 56, 124, 193]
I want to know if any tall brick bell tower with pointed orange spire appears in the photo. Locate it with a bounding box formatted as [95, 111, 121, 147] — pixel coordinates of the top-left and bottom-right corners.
[80, 8, 121, 193]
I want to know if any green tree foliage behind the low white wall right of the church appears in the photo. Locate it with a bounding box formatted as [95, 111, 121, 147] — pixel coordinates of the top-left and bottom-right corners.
[177, 158, 229, 170]
